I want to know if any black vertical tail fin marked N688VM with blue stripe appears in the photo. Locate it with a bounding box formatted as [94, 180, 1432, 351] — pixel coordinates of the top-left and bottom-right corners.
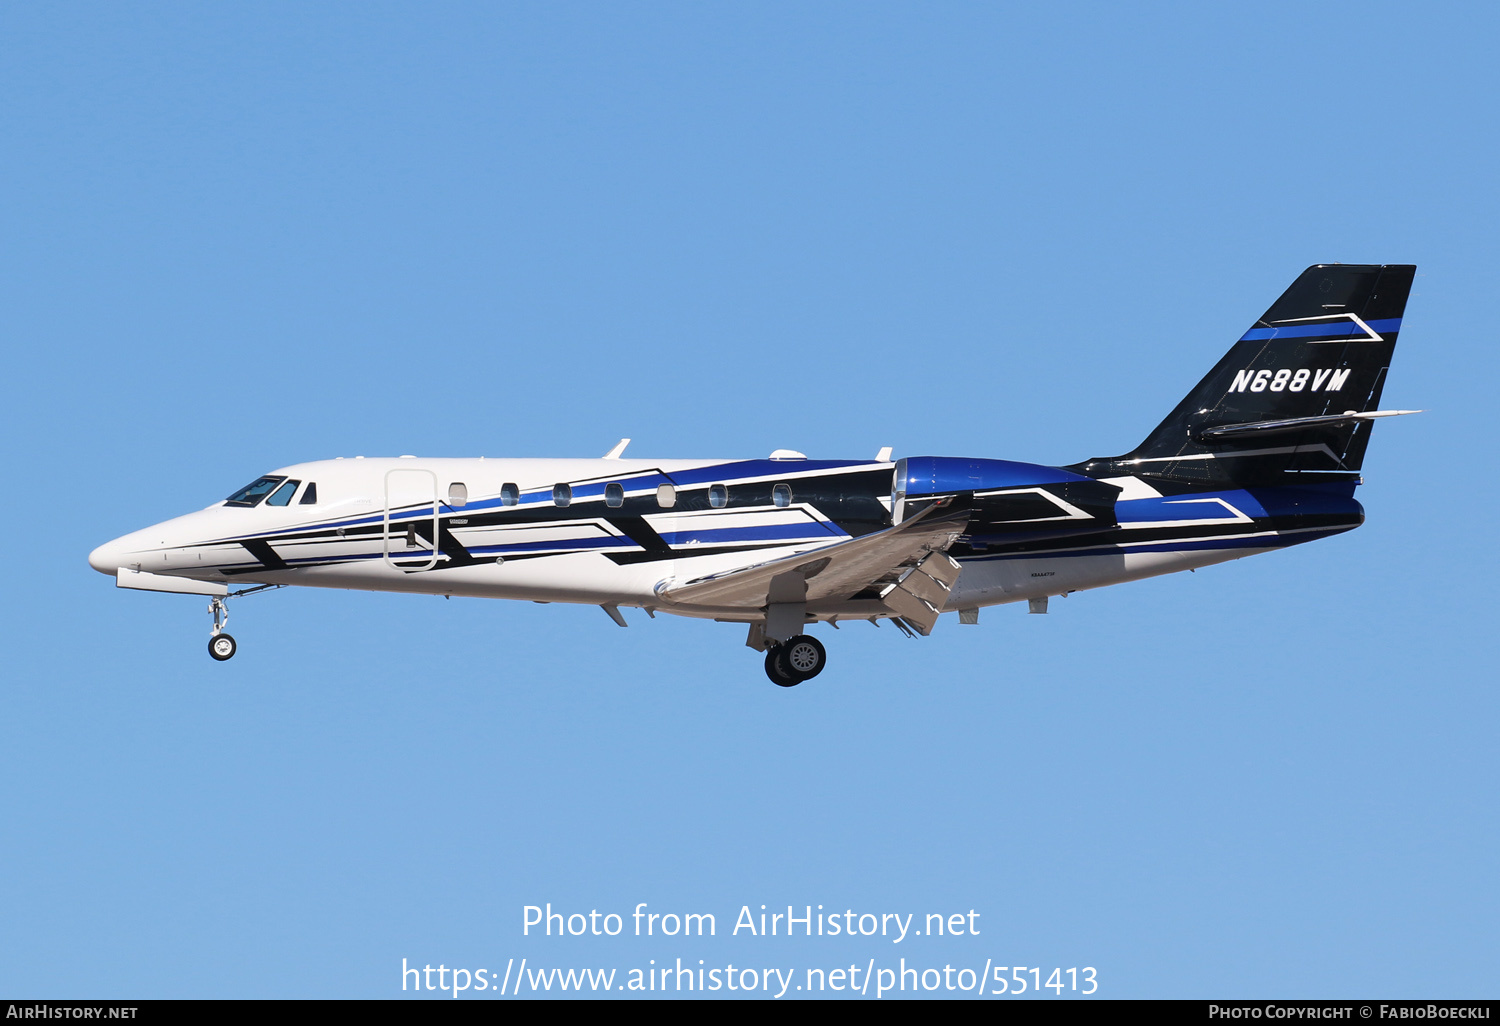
[1080, 264, 1416, 485]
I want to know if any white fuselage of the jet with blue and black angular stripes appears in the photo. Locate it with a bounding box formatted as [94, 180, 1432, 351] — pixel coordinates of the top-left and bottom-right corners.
[90, 458, 1364, 621]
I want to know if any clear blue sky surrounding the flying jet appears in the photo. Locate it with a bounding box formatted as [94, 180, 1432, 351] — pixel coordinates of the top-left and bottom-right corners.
[0, 3, 1500, 998]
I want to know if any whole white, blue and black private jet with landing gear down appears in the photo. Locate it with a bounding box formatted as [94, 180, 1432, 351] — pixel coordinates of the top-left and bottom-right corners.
[89, 264, 1416, 687]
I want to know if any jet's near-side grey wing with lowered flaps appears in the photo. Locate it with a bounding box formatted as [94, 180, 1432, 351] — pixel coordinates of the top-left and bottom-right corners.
[660, 500, 969, 635]
